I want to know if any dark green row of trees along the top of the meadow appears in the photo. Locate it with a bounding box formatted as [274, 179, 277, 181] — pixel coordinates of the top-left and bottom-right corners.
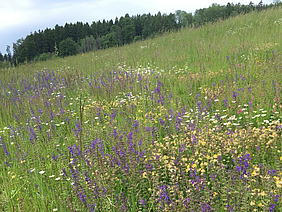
[0, 0, 282, 68]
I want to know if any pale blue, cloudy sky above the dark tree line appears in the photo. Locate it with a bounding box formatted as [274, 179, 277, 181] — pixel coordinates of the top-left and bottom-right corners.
[0, 0, 273, 54]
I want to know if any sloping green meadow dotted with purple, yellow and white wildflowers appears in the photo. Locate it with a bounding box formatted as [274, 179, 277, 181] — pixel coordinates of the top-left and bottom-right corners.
[0, 7, 282, 212]
